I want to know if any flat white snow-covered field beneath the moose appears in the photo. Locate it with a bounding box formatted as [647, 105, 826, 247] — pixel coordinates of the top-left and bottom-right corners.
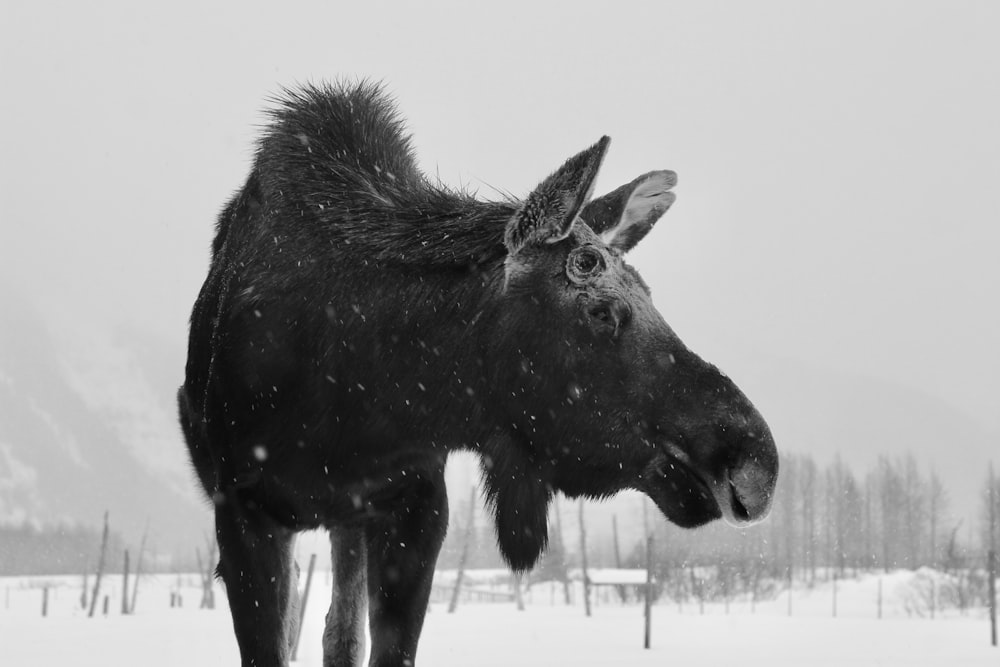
[0, 573, 1000, 667]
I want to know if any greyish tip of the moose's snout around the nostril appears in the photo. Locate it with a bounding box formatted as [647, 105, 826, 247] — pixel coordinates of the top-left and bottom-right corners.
[719, 435, 778, 525]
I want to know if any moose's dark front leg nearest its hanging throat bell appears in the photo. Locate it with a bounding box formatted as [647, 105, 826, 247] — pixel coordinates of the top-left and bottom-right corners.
[368, 470, 448, 667]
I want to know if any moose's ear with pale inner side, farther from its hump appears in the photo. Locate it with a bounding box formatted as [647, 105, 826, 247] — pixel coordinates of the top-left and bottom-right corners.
[580, 171, 677, 252]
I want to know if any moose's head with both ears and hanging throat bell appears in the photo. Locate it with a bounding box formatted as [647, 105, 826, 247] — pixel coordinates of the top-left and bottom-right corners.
[487, 137, 778, 567]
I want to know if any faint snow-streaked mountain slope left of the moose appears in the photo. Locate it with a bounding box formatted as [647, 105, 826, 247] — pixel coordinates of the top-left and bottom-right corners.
[0, 290, 209, 552]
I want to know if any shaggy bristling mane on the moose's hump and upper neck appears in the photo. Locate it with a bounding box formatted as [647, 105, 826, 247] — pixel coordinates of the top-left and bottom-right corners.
[254, 81, 520, 267]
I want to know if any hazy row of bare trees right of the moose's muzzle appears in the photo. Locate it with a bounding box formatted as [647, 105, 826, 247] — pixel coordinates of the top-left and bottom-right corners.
[644, 455, 1000, 581]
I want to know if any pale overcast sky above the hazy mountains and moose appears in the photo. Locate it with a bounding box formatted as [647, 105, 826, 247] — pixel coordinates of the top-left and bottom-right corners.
[0, 0, 1000, 430]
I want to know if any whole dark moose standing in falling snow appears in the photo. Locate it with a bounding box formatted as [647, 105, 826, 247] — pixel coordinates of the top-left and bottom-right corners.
[178, 82, 778, 667]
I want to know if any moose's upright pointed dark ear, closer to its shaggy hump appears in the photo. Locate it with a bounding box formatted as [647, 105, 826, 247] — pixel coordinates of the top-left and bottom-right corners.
[503, 137, 611, 255]
